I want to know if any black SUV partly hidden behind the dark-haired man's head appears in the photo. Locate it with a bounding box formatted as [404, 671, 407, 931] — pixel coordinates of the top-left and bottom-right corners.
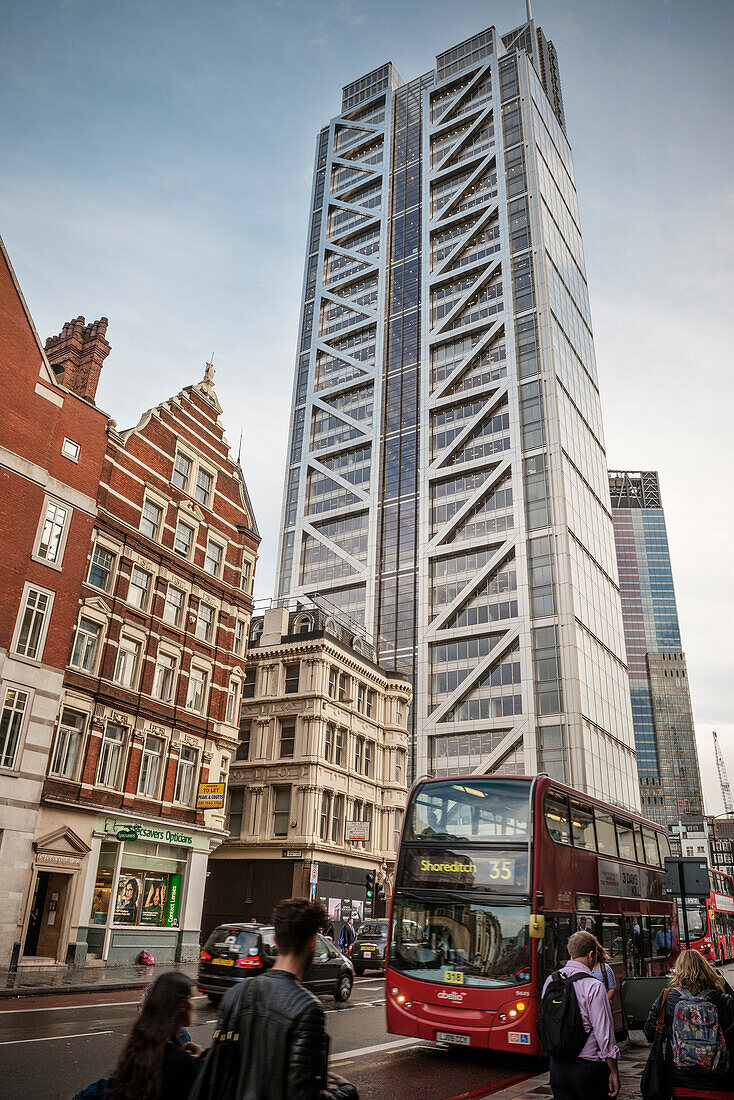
[197, 924, 354, 1004]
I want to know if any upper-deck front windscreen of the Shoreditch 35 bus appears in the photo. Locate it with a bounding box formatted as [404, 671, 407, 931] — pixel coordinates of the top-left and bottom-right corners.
[404, 778, 530, 842]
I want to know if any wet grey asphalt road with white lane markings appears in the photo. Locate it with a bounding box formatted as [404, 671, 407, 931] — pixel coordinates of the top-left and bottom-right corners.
[0, 976, 537, 1100]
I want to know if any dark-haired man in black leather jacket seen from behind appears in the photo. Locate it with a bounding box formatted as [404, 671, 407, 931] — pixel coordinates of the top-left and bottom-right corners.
[219, 898, 358, 1100]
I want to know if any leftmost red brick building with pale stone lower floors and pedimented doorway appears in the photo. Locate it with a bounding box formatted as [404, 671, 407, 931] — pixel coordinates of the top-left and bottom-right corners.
[0, 240, 109, 967]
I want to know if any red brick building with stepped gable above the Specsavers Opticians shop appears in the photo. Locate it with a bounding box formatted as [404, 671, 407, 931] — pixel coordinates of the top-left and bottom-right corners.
[37, 354, 260, 961]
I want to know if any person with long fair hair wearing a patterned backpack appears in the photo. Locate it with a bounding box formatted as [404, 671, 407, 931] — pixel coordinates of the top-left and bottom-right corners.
[645, 950, 734, 1100]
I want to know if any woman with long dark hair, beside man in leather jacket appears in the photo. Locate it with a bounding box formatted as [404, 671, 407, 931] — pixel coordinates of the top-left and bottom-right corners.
[109, 971, 199, 1100]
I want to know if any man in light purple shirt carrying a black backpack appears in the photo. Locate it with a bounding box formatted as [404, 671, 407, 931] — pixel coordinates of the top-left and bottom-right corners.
[538, 932, 620, 1100]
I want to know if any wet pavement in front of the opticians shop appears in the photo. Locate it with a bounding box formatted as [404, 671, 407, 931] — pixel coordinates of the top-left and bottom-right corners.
[0, 959, 198, 999]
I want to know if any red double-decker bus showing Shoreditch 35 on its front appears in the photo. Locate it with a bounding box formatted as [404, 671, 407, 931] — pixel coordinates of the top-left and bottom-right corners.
[385, 776, 678, 1054]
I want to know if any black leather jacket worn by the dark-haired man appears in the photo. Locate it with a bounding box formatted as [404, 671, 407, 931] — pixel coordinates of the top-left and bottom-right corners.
[219, 970, 358, 1100]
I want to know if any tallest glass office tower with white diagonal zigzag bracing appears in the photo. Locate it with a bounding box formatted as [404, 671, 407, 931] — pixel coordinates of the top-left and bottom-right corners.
[277, 15, 638, 807]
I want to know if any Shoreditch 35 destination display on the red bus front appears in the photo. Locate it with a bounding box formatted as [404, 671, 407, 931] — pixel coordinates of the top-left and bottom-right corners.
[402, 847, 527, 893]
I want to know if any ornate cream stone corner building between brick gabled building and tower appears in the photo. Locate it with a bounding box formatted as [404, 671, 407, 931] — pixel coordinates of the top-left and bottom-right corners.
[202, 601, 412, 932]
